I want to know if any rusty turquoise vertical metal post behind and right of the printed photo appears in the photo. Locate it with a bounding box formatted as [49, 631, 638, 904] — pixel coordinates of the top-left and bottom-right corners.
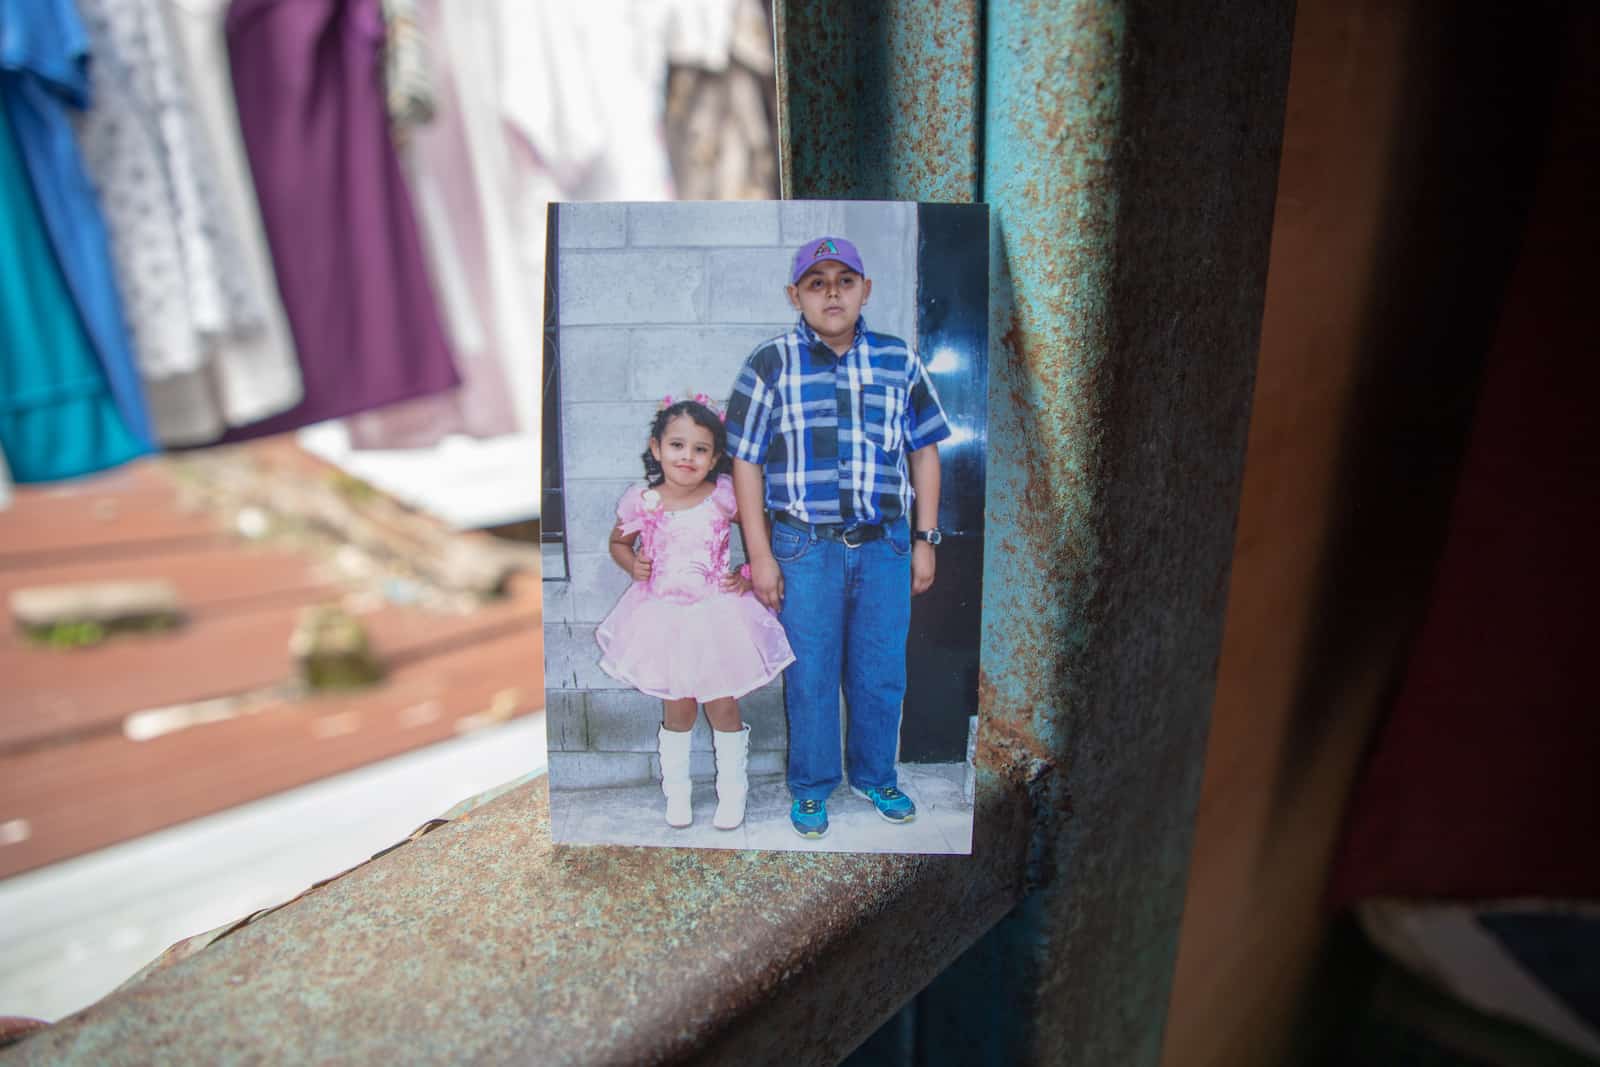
[784, 0, 1293, 1064]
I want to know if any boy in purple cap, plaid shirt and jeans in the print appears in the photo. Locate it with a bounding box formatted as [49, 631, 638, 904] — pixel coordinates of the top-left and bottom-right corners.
[726, 237, 950, 838]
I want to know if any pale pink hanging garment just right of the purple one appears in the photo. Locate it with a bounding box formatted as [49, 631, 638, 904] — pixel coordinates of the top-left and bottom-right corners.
[346, 0, 521, 448]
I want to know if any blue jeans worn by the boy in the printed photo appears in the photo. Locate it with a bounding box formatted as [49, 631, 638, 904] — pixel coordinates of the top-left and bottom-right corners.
[771, 518, 910, 800]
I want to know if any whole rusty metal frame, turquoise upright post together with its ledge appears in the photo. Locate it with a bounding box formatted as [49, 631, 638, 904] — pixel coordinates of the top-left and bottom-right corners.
[0, 0, 1293, 1064]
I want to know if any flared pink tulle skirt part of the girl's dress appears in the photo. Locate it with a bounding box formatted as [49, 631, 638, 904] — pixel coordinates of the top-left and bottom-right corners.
[595, 584, 795, 702]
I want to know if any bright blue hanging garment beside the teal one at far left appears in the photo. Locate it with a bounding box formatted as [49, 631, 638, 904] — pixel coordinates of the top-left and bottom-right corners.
[0, 0, 155, 454]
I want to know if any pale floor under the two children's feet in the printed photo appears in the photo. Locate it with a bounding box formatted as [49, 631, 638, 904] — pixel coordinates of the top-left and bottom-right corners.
[550, 763, 973, 854]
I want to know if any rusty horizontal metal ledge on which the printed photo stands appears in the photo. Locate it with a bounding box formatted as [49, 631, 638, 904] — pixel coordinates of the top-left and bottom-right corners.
[0, 773, 1030, 1064]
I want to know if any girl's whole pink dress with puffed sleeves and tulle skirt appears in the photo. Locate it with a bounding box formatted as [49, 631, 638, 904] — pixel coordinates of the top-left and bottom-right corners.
[595, 475, 795, 702]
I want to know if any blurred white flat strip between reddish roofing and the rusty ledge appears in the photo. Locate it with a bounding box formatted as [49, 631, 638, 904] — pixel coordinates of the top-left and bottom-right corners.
[0, 712, 547, 1022]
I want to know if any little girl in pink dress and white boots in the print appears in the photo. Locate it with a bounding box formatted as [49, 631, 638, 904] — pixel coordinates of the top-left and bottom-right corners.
[595, 394, 794, 830]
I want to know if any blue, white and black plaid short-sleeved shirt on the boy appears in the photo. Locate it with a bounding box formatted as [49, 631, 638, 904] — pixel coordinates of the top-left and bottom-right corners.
[728, 318, 950, 526]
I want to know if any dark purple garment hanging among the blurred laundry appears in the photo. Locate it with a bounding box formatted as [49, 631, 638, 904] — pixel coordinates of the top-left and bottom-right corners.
[222, 0, 459, 442]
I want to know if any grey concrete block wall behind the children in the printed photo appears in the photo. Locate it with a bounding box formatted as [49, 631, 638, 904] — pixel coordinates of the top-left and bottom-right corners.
[544, 202, 917, 789]
